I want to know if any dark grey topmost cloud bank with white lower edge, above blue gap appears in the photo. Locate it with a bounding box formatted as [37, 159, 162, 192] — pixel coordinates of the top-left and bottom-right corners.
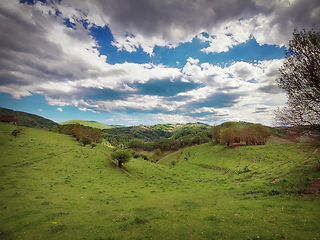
[45, 0, 320, 55]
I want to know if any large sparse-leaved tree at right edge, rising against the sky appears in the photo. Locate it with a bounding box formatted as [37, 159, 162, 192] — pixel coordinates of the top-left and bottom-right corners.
[274, 27, 320, 134]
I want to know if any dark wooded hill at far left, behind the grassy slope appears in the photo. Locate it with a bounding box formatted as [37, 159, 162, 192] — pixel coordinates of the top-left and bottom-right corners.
[0, 107, 59, 130]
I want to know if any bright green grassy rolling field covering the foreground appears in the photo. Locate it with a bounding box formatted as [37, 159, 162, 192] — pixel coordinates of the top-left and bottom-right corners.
[0, 124, 320, 240]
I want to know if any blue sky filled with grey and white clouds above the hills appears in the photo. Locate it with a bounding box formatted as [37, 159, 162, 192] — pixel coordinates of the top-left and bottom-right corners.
[0, 0, 320, 126]
